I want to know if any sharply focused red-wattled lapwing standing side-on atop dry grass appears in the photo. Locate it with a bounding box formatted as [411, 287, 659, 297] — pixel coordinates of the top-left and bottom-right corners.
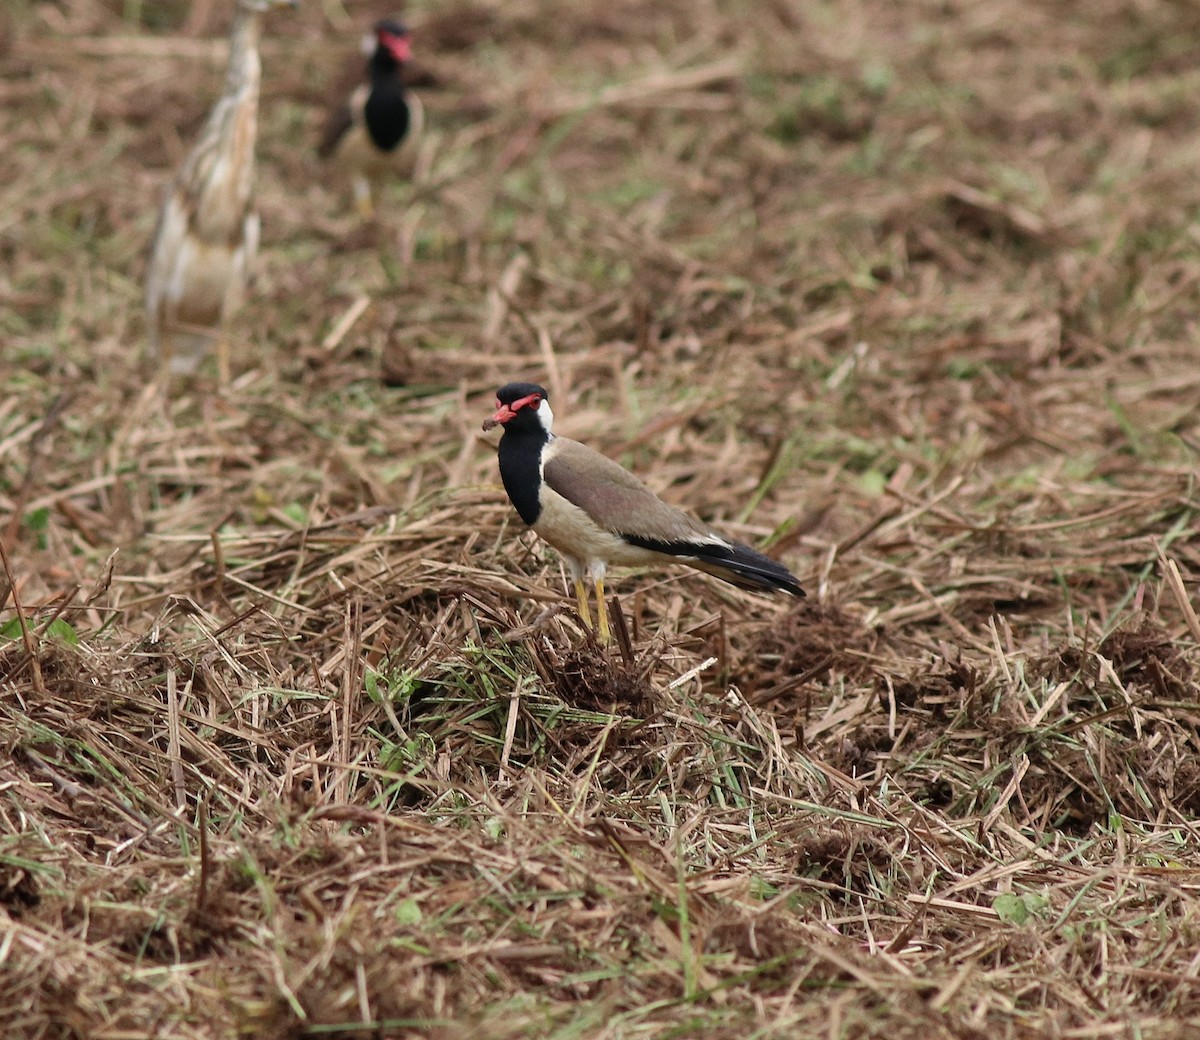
[484, 383, 804, 643]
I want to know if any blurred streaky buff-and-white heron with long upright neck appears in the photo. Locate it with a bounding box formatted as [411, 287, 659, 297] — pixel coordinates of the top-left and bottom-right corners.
[145, 0, 296, 386]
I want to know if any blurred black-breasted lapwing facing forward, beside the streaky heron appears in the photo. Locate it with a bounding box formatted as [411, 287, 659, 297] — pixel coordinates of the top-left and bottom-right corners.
[317, 18, 425, 217]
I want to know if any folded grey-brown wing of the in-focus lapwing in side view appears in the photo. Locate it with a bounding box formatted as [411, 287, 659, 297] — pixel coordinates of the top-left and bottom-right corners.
[542, 437, 725, 545]
